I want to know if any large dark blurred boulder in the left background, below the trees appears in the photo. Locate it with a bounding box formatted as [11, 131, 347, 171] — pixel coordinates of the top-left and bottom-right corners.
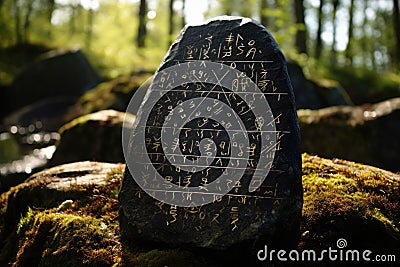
[6, 50, 100, 115]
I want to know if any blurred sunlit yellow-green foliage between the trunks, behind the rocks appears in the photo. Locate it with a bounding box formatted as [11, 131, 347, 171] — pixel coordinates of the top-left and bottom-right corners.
[0, 0, 400, 103]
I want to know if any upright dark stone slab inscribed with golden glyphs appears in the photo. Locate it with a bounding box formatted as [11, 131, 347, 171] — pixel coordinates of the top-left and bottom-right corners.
[119, 17, 302, 252]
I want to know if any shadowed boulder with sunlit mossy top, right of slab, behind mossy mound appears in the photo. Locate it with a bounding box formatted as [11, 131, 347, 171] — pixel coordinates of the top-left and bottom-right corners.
[297, 98, 400, 171]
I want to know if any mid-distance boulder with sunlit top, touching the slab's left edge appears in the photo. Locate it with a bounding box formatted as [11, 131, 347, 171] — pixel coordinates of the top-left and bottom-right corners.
[49, 110, 135, 166]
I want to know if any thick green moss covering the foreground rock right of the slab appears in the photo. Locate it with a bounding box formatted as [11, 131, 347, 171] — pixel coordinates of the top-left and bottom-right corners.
[300, 154, 400, 252]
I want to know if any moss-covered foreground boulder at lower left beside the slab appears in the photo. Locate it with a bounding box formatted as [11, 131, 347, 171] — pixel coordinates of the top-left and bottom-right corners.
[0, 162, 123, 266]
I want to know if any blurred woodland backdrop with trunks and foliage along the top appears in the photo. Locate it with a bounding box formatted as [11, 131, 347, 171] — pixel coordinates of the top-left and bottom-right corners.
[0, 0, 400, 78]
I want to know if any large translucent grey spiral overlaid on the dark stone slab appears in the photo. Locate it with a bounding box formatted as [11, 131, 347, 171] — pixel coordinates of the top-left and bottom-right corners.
[122, 61, 276, 207]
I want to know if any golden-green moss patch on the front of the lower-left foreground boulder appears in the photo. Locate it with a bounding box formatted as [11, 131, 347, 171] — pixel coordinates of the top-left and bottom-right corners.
[15, 212, 120, 266]
